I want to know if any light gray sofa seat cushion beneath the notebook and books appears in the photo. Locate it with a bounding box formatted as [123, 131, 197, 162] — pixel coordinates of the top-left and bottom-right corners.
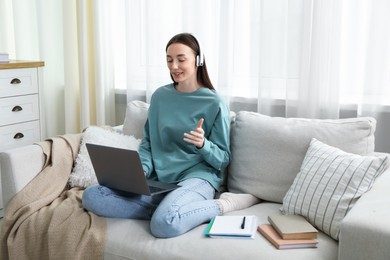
[104, 202, 338, 260]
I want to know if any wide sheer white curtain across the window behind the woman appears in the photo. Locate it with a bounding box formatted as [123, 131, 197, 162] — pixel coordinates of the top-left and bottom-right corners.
[117, 0, 390, 151]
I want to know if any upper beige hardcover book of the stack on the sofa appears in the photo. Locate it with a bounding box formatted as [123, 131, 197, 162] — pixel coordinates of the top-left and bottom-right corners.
[268, 215, 318, 239]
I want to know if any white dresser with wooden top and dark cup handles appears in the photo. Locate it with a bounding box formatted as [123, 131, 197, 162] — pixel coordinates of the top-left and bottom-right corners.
[0, 61, 45, 217]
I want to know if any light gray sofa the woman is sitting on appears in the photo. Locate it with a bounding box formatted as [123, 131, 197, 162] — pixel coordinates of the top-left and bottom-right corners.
[0, 102, 390, 260]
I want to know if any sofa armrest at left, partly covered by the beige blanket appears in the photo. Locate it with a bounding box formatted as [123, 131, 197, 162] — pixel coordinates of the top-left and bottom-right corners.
[0, 145, 45, 208]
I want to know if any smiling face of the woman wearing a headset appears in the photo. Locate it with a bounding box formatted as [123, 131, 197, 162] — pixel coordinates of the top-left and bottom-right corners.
[167, 43, 197, 84]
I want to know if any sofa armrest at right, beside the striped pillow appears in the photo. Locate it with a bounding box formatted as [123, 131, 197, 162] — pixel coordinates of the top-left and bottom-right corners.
[339, 169, 390, 260]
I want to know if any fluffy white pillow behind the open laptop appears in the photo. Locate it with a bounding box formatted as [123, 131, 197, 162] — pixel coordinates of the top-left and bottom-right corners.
[68, 126, 141, 188]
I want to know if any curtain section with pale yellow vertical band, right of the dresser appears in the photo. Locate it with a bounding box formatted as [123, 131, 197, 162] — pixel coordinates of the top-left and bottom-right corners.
[63, 0, 115, 133]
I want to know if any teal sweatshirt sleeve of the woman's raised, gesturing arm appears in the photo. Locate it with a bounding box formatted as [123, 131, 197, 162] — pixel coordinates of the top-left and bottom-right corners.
[198, 102, 230, 170]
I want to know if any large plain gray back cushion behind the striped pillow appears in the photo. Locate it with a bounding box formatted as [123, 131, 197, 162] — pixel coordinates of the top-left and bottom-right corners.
[228, 111, 376, 203]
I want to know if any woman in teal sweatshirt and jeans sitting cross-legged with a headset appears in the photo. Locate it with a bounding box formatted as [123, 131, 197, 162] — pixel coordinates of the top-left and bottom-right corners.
[83, 33, 258, 238]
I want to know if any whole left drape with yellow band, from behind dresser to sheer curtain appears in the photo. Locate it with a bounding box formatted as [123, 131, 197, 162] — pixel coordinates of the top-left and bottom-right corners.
[0, 0, 115, 136]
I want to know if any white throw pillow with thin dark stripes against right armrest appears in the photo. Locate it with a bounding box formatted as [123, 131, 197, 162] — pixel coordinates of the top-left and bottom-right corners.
[281, 138, 387, 240]
